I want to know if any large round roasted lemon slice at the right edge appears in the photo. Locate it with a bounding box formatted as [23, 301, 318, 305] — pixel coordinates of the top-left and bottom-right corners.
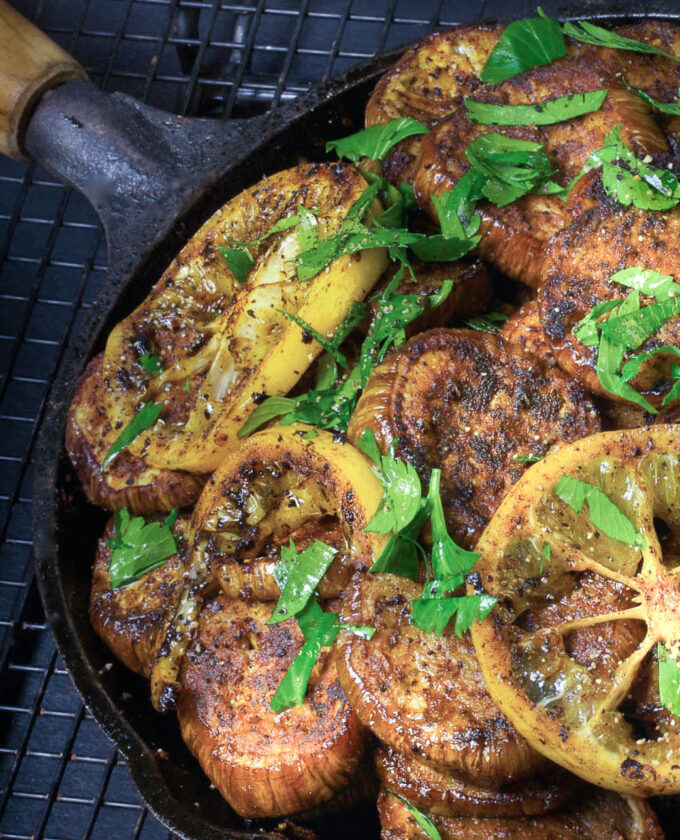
[470, 425, 680, 796]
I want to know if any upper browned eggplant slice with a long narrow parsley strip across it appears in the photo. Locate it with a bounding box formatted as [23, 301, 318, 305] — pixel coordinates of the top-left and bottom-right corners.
[414, 57, 669, 287]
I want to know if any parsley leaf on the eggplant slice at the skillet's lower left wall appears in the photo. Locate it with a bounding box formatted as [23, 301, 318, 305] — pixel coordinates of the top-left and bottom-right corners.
[109, 508, 177, 589]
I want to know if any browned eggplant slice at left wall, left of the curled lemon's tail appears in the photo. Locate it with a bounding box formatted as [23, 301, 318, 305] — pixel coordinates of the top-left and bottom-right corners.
[90, 513, 190, 678]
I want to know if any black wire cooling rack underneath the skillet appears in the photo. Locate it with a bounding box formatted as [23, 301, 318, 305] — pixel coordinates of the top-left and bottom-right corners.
[0, 0, 548, 840]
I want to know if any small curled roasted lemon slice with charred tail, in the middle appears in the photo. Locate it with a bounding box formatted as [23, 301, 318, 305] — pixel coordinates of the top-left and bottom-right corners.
[151, 425, 387, 709]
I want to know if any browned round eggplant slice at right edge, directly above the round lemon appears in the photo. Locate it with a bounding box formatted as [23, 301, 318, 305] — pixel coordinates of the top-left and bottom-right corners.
[539, 205, 680, 408]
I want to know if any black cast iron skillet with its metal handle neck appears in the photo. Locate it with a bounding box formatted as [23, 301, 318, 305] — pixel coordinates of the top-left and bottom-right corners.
[15, 0, 680, 840]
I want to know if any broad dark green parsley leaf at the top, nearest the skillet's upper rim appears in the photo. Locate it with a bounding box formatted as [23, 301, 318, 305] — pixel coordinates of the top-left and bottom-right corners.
[479, 17, 567, 85]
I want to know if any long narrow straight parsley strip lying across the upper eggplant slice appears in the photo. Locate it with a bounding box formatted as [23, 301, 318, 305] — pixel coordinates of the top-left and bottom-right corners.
[464, 89, 609, 125]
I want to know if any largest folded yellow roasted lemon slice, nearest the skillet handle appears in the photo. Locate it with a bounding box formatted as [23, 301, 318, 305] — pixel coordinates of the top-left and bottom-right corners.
[104, 163, 387, 473]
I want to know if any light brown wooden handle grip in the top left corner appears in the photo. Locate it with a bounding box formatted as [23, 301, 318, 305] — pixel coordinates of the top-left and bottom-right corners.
[0, 0, 86, 158]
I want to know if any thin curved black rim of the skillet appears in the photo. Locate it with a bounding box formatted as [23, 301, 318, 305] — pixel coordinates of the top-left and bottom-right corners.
[27, 9, 680, 840]
